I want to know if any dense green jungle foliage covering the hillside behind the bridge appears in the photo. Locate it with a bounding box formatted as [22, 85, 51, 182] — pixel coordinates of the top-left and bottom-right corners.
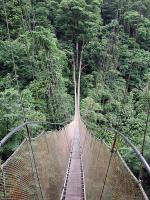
[0, 0, 150, 197]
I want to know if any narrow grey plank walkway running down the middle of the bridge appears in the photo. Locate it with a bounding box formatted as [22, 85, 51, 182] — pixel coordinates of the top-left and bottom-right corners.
[62, 125, 85, 200]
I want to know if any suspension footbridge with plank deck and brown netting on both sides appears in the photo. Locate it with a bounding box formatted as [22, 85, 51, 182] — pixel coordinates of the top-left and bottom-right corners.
[0, 111, 150, 200]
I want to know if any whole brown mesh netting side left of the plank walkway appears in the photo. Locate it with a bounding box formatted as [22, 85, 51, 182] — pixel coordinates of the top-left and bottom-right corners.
[0, 124, 71, 200]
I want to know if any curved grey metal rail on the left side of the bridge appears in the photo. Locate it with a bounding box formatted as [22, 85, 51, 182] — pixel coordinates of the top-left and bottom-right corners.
[0, 119, 72, 147]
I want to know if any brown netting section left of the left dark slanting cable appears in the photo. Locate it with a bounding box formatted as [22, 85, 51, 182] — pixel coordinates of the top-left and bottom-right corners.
[2, 140, 38, 200]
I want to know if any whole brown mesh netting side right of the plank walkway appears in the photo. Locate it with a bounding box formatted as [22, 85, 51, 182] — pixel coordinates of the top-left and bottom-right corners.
[80, 123, 146, 200]
